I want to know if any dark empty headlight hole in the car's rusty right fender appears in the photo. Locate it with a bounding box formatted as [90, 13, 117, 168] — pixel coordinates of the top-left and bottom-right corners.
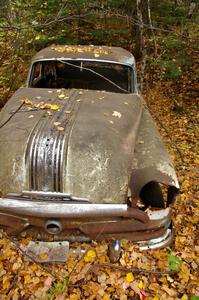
[140, 181, 165, 208]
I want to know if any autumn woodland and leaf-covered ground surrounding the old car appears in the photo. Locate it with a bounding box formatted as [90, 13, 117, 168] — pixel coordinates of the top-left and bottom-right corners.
[0, 0, 199, 300]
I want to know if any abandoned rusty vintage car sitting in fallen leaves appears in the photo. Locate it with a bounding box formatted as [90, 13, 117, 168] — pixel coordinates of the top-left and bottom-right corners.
[0, 46, 179, 258]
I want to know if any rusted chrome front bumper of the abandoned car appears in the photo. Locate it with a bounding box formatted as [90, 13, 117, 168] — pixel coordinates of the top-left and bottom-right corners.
[0, 192, 173, 249]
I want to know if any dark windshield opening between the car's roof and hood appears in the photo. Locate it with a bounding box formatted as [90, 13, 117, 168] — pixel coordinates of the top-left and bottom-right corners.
[29, 60, 135, 93]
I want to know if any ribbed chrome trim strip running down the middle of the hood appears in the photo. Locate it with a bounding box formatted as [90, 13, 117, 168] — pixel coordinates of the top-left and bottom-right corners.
[26, 90, 80, 192]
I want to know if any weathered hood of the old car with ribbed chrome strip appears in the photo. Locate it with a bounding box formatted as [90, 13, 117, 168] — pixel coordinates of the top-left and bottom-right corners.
[0, 88, 142, 203]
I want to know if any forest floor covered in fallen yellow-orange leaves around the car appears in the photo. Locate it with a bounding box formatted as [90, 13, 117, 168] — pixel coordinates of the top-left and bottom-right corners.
[0, 82, 199, 300]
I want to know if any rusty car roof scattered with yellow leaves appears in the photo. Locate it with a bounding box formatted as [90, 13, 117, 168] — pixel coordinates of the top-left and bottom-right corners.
[32, 45, 135, 66]
